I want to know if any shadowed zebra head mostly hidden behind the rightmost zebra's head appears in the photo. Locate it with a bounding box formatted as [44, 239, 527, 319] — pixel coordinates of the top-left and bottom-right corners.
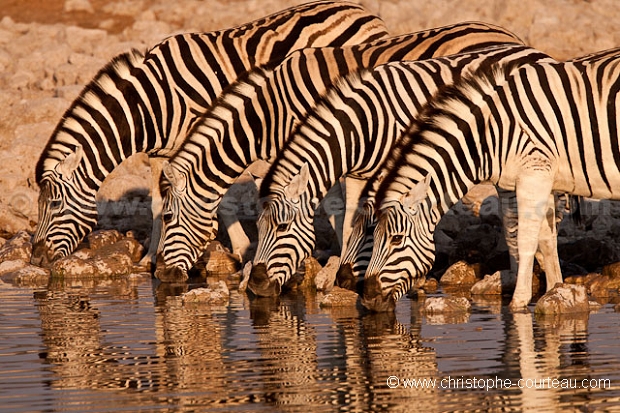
[336, 199, 377, 290]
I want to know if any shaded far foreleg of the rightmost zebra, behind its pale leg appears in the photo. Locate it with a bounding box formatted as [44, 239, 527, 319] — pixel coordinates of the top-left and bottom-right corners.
[537, 194, 562, 291]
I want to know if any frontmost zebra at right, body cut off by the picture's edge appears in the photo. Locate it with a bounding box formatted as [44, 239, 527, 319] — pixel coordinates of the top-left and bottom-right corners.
[362, 50, 620, 311]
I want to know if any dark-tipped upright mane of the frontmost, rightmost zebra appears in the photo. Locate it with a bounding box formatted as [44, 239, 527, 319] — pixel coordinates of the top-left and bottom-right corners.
[375, 62, 518, 211]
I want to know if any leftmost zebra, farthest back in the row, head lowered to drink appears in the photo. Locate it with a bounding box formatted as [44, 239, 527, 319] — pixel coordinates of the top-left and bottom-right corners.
[31, 1, 388, 265]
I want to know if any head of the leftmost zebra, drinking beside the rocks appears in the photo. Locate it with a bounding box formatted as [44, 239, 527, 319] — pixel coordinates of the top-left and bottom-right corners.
[30, 145, 97, 266]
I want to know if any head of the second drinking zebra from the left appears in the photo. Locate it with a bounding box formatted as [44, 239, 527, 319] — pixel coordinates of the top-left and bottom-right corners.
[155, 161, 220, 281]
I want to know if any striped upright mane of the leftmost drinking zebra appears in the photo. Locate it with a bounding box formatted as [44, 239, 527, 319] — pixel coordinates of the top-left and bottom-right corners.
[35, 49, 144, 183]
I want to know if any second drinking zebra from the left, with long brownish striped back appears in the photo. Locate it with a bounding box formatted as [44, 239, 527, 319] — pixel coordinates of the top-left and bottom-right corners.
[155, 22, 523, 281]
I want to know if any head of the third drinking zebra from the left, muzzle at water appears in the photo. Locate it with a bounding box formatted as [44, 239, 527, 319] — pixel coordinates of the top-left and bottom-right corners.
[248, 164, 318, 297]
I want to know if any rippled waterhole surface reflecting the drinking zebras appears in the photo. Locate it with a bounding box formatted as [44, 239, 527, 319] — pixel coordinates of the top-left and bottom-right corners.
[0, 277, 620, 412]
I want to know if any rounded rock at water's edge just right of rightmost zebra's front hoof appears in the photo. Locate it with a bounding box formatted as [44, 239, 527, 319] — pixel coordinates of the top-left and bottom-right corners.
[534, 284, 590, 314]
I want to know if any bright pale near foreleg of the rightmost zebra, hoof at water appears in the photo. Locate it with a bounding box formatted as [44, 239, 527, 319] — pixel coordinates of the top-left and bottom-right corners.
[510, 171, 553, 310]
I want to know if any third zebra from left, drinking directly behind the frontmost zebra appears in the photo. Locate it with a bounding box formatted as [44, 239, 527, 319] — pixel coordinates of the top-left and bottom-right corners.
[248, 45, 553, 296]
